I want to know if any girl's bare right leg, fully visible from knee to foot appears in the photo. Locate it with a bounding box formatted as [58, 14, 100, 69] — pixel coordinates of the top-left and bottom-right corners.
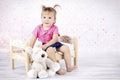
[59, 45, 75, 72]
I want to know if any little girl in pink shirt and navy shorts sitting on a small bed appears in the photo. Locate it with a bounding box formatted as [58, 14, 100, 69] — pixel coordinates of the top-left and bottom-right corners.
[30, 5, 75, 75]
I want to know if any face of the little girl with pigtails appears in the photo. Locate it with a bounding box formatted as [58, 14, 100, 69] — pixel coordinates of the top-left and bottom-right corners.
[41, 12, 55, 28]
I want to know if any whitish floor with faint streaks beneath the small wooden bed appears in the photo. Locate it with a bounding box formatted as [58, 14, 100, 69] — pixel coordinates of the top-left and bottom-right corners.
[0, 52, 120, 80]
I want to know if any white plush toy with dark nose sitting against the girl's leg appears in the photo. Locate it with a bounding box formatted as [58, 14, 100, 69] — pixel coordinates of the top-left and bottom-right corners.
[26, 47, 60, 78]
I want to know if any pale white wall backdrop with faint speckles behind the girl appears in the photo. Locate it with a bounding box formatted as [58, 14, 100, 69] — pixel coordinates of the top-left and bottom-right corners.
[0, 0, 120, 52]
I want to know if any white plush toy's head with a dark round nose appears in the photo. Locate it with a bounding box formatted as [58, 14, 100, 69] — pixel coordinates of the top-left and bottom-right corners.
[32, 47, 47, 62]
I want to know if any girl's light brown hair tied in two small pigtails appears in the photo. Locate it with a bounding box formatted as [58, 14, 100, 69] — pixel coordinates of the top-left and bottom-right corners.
[41, 4, 60, 18]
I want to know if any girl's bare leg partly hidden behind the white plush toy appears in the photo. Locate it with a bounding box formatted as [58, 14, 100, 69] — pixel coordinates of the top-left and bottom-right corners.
[46, 47, 66, 75]
